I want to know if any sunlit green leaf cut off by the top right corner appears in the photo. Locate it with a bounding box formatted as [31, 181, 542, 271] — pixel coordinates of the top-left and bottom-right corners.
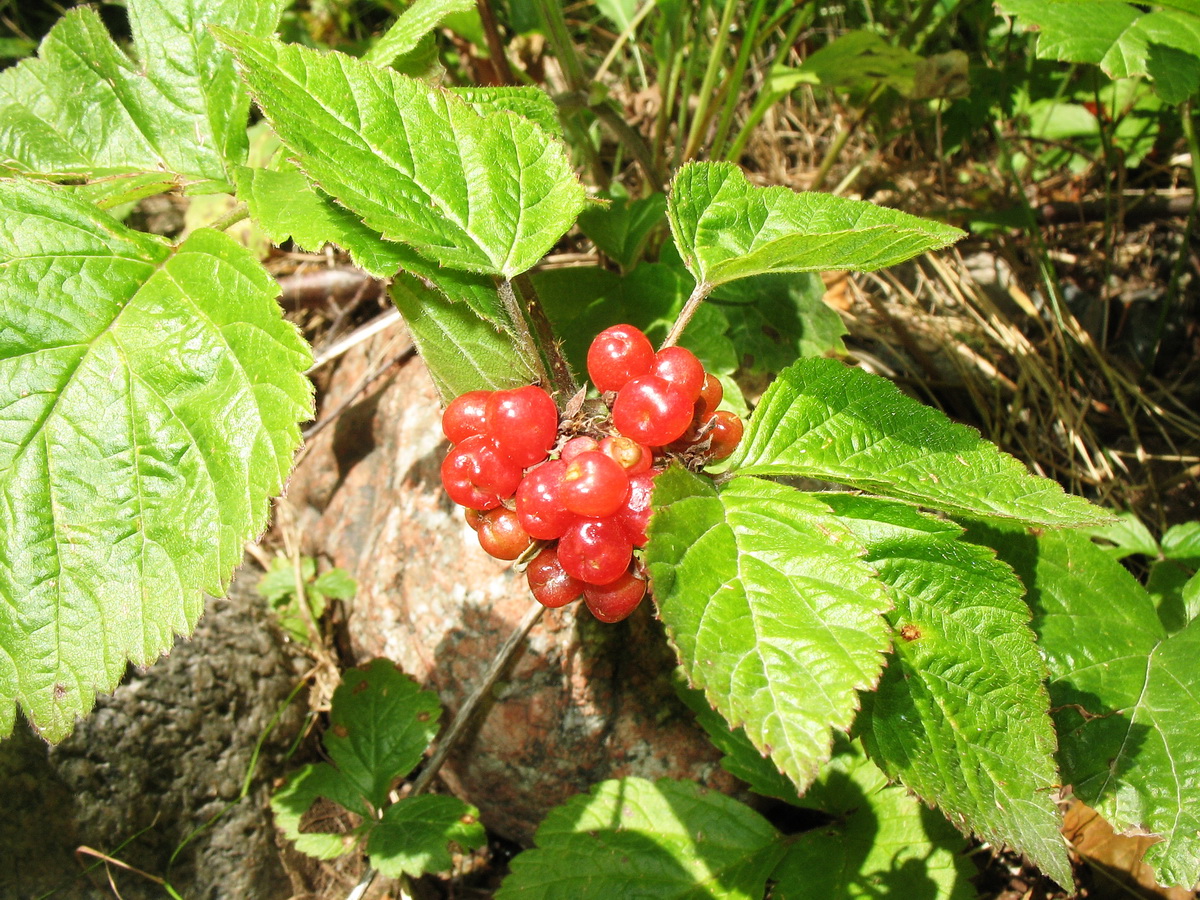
[996, 0, 1200, 103]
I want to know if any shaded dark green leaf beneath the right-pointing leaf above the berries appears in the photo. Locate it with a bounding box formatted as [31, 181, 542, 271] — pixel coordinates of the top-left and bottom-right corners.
[707, 272, 848, 374]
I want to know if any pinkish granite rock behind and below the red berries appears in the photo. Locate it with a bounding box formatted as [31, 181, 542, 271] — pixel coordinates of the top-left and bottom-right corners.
[288, 328, 737, 842]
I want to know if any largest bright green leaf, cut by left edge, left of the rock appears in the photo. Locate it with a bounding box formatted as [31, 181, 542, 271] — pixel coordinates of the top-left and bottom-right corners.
[0, 182, 312, 740]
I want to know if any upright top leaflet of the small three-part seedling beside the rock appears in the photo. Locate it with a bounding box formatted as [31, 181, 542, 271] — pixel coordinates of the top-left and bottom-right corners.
[324, 659, 442, 809]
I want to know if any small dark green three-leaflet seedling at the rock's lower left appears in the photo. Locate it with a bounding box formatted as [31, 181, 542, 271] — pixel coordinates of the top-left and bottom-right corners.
[271, 659, 486, 877]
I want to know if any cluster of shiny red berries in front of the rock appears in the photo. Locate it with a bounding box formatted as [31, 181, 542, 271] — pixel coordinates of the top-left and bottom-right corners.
[442, 325, 742, 622]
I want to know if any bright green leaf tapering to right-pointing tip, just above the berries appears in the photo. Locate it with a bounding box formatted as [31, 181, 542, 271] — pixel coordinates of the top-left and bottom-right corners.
[667, 162, 962, 286]
